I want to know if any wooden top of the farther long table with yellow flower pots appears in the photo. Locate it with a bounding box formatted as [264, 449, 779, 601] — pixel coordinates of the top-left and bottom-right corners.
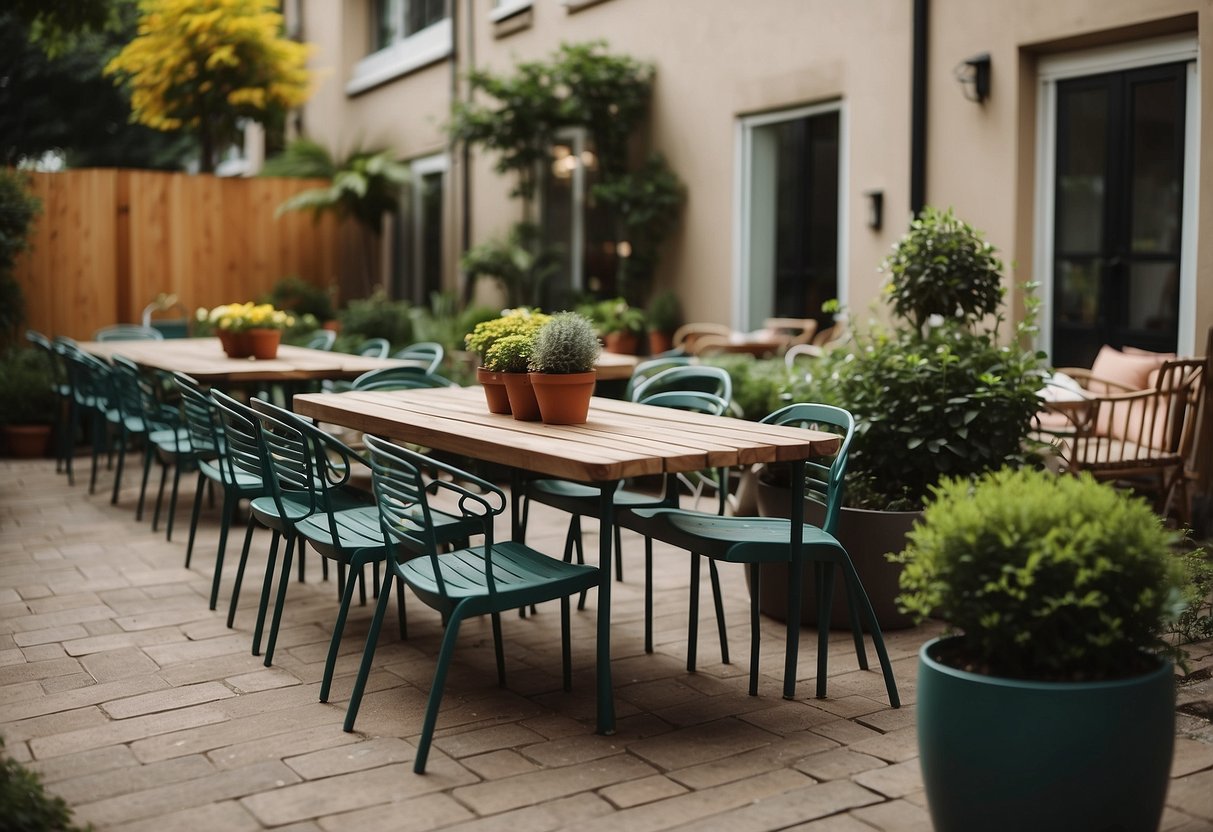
[79, 338, 417, 384]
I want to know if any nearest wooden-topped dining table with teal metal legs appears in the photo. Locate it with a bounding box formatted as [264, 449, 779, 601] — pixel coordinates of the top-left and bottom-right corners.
[294, 387, 839, 734]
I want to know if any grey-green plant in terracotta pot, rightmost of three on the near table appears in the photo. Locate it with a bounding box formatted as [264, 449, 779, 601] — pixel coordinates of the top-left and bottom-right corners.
[530, 312, 602, 424]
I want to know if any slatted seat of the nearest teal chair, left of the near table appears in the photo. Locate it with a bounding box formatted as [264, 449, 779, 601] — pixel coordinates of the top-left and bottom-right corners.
[399, 542, 598, 615]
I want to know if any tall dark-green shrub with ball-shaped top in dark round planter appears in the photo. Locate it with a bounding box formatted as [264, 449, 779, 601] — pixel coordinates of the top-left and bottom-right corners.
[758, 207, 1044, 629]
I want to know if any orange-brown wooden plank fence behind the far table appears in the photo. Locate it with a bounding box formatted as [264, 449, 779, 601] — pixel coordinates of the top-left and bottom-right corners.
[17, 169, 341, 340]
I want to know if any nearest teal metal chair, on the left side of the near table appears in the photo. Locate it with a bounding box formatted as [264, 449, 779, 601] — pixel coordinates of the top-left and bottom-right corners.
[344, 437, 601, 774]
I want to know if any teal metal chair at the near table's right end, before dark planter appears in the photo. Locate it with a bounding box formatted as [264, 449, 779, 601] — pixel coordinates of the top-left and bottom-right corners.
[620, 404, 901, 707]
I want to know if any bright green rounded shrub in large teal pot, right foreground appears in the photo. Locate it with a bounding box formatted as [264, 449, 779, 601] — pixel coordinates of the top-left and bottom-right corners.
[896, 468, 1184, 832]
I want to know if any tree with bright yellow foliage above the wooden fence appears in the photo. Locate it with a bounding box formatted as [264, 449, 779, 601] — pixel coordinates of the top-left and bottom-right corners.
[106, 0, 311, 172]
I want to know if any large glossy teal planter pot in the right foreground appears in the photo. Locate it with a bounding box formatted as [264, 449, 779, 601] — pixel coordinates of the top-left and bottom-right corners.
[916, 639, 1175, 832]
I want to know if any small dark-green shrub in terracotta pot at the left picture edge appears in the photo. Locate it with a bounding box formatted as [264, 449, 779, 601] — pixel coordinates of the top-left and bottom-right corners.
[0, 348, 59, 457]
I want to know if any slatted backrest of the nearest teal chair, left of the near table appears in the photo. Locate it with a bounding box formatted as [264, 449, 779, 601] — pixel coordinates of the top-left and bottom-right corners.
[364, 434, 506, 594]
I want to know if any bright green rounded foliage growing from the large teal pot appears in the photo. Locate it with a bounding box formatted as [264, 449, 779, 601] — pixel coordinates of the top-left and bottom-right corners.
[893, 468, 1184, 682]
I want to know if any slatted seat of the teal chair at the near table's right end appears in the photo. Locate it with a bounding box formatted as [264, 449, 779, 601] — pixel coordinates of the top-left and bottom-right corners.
[619, 508, 843, 563]
